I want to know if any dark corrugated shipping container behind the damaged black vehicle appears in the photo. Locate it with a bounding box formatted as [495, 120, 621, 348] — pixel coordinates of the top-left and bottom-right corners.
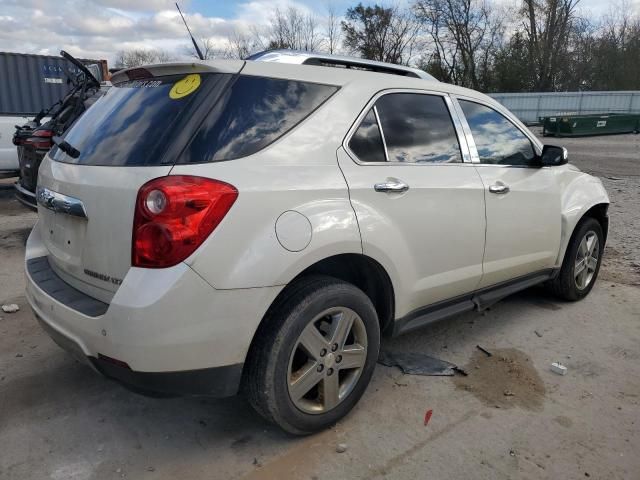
[0, 52, 107, 116]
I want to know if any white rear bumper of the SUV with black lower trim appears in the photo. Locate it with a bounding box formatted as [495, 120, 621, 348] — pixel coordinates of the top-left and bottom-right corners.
[25, 221, 280, 396]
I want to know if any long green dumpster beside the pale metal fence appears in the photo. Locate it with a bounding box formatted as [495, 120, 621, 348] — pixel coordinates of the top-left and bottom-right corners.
[542, 113, 640, 137]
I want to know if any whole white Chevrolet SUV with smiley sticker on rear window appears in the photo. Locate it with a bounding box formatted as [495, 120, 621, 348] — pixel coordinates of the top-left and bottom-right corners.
[25, 54, 609, 434]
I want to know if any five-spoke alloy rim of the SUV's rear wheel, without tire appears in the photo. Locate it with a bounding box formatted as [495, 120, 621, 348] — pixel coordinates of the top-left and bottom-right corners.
[287, 307, 367, 414]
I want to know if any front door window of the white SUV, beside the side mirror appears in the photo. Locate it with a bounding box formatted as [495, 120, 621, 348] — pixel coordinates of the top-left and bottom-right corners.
[460, 100, 536, 166]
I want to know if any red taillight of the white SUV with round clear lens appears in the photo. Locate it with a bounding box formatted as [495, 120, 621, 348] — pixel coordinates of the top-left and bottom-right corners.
[131, 175, 238, 268]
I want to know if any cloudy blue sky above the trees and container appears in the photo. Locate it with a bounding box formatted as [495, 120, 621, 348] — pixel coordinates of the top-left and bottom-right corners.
[0, 0, 640, 63]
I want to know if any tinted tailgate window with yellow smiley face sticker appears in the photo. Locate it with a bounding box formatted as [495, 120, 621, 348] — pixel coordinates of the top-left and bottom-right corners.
[52, 74, 232, 165]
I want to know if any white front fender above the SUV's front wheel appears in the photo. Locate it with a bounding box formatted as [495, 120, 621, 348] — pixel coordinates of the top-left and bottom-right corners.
[556, 168, 609, 267]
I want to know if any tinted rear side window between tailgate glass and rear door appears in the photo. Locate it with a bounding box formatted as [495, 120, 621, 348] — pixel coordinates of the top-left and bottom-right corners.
[179, 76, 338, 163]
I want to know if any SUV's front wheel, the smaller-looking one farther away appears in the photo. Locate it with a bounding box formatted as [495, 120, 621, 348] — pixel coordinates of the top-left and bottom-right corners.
[548, 217, 604, 301]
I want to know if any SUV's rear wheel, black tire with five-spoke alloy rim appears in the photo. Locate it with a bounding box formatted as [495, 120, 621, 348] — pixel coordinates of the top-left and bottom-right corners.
[245, 276, 380, 435]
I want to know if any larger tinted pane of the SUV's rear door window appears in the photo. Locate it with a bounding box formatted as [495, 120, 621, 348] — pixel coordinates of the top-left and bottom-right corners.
[376, 93, 462, 163]
